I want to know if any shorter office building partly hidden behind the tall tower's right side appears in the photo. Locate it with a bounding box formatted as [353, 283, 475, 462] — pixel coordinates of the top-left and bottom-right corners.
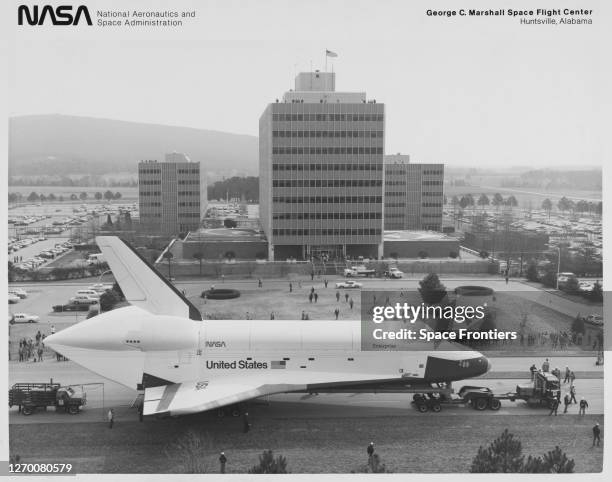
[385, 154, 444, 231]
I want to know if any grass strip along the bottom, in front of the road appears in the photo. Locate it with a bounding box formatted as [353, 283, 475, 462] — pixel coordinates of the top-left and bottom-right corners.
[9, 413, 603, 473]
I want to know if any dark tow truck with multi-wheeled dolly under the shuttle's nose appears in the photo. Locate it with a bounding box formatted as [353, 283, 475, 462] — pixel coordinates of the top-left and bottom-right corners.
[412, 372, 561, 413]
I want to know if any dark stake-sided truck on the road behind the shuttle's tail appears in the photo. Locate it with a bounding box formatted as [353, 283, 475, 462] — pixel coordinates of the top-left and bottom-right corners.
[9, 382, 87, 415]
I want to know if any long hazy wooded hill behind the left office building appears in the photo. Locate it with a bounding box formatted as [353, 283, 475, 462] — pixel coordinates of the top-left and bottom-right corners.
[9, 115, 258, 178]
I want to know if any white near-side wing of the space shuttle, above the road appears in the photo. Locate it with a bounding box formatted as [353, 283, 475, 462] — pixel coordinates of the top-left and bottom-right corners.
[143, 377, 306, 415]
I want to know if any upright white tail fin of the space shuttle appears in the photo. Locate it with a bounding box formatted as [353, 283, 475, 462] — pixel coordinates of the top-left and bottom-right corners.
[96, 236, 202, 321]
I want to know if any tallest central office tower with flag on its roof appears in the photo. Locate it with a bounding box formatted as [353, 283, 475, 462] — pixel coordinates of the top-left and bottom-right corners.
[259, 71, 385, 260]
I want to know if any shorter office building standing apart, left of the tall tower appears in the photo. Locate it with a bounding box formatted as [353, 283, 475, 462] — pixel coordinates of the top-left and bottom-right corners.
[138, 152, 207, 235]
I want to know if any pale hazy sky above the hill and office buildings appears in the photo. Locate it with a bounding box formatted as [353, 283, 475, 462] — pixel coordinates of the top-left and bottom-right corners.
[9, 0, 605, 166]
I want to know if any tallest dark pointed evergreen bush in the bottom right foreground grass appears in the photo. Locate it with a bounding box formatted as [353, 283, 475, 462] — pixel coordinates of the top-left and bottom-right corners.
[470, 429, 524, 473]
